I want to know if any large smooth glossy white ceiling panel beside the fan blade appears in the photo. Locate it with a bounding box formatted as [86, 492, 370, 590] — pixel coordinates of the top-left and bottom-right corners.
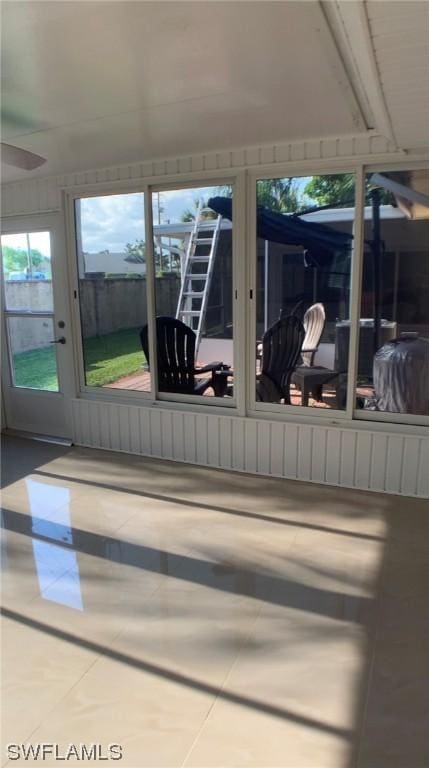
[2, 0, 366, 181]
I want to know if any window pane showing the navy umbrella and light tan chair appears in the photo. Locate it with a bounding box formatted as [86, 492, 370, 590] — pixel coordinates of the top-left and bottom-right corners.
[256, 174, 355, 409]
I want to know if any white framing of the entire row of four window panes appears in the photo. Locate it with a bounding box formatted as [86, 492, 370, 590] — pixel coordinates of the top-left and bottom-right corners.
[63, 157, 429, 428]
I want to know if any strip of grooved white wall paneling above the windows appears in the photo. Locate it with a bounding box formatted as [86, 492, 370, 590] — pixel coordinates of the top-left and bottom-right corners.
[1, 134, 403, 216]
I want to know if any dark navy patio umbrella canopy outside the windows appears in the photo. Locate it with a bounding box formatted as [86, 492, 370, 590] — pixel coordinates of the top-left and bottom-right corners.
[208, 197, 353, 266]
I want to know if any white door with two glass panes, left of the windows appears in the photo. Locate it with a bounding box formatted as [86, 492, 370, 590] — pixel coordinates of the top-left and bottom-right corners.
[1, 218, 74, 438]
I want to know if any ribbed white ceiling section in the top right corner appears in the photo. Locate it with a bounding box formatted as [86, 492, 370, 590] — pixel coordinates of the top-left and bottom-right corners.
[322, 0, 429, 151]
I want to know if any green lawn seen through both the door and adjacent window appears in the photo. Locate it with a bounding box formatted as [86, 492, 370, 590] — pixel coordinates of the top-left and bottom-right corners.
[13, 328, 145, 392]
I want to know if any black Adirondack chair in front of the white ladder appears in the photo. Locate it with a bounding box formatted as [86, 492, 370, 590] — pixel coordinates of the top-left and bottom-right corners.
[140, 317, 229, 397]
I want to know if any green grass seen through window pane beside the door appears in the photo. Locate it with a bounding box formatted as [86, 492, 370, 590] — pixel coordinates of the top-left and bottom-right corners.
[83, 328, 145, 387]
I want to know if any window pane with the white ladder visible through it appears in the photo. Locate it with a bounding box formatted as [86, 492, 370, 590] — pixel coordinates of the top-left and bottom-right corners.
[152, 186, 234, 398]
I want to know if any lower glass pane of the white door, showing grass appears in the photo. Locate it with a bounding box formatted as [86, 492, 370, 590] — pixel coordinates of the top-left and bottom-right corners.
[6, 317, 59, 392]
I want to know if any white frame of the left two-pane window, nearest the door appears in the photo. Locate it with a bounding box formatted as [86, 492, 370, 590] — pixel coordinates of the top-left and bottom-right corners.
[64, 169, 246, 416]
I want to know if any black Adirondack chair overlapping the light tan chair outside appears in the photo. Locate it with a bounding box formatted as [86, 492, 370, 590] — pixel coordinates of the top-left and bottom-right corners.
[256, 315, 305, 405]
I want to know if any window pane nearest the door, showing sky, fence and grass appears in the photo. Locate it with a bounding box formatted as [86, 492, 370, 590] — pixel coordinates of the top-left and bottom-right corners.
[75, 193, 150, 391]
